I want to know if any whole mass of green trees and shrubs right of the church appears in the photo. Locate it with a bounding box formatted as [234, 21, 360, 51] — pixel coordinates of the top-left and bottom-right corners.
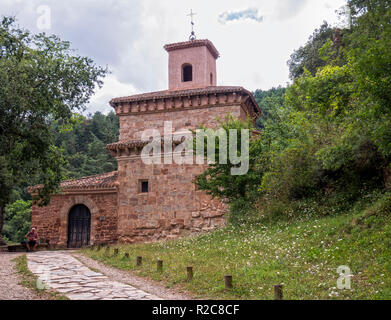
[199, 0, 391, 224]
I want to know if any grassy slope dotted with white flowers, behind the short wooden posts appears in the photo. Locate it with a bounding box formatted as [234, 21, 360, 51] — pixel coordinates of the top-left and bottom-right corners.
[83, 191, 391, 300]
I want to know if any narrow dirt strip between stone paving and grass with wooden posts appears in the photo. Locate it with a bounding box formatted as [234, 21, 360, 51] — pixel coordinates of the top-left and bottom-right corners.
[72, 253, 194, 300]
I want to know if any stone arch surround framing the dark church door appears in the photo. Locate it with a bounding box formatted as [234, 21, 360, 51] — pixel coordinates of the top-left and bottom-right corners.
[58, 195, 99, 247]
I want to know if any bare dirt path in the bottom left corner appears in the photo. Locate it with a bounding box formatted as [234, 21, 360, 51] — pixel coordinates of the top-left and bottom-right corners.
[0, 252, 40, 300]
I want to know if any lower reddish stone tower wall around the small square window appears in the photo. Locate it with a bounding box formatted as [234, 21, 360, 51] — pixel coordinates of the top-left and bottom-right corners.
[118, 158, 227, 243]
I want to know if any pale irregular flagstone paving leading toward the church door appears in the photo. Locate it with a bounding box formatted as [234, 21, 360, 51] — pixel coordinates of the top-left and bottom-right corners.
[27, 251, 160, 300]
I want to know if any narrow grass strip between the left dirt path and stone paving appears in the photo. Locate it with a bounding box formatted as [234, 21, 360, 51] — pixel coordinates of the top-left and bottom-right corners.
[14, 254, 69, 300]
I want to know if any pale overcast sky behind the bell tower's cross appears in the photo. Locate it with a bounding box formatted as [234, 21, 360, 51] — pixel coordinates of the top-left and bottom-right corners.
[0, 0, 346, 113]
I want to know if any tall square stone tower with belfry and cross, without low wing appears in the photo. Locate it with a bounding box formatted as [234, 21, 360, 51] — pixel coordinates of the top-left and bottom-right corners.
[107, 13, 261, 243]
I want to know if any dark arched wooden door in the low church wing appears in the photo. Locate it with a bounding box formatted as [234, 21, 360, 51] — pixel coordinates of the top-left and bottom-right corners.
[68, 204, 91, 248]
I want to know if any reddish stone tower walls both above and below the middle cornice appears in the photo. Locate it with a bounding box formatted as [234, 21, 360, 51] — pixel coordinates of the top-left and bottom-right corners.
[117, 105, 246, 243]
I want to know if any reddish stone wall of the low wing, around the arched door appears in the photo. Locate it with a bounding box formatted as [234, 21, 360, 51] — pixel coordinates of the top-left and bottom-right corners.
[32, 193, 118, 247]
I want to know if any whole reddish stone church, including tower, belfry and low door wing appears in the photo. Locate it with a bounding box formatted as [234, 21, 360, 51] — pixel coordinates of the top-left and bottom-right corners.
[29, 39, 261, 247]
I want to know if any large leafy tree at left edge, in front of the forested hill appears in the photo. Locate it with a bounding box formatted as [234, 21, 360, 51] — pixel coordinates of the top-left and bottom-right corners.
[0, 17, 107, 242]
